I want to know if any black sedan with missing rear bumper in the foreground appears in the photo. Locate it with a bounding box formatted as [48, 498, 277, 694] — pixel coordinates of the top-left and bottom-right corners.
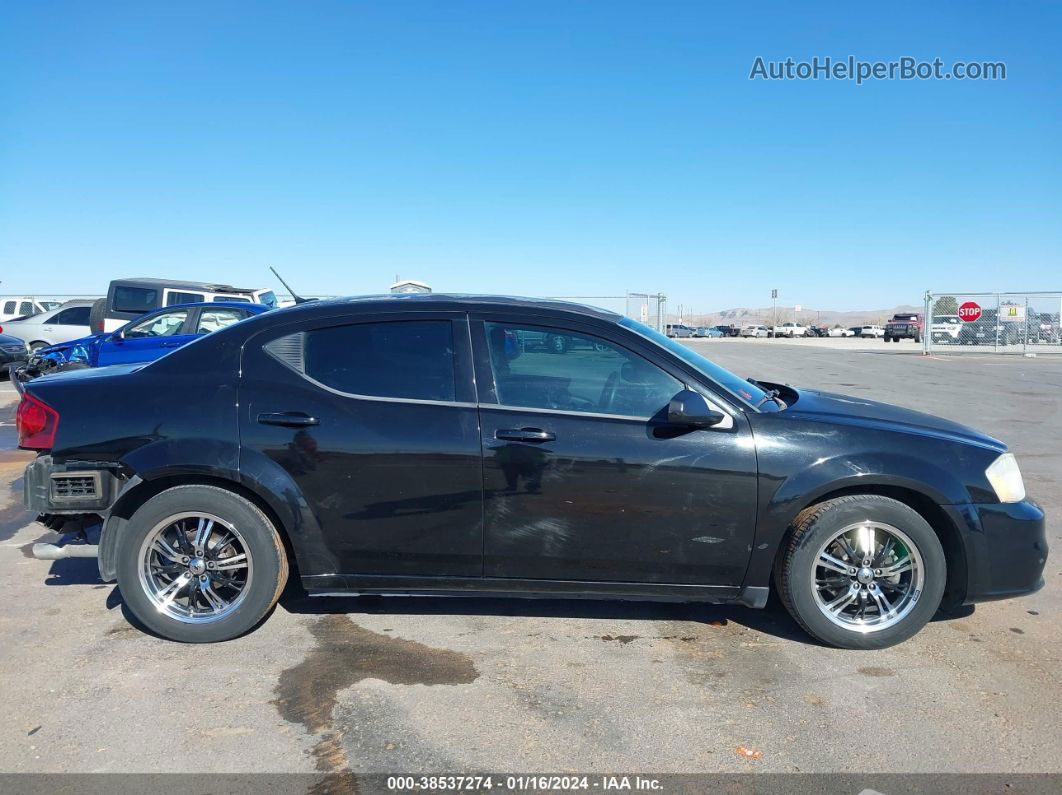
[17, 295, 1047, 649]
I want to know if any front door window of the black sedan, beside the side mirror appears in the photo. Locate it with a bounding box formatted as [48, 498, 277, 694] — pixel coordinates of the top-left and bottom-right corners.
[486, 323, 683, 418]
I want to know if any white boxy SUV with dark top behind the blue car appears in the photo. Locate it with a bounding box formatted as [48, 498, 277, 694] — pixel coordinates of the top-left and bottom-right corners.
[89, 278, 278, 334]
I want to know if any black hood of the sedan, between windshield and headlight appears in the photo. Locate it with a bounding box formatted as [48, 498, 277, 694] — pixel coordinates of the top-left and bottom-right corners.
[783, 386, 1007, 452]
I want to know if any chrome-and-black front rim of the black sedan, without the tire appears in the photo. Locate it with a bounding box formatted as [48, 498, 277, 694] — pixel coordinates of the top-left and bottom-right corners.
[811, 520, 925, 633]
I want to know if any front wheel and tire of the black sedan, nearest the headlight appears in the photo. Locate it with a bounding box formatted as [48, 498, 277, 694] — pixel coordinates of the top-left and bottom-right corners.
[774, 495, 947, 650]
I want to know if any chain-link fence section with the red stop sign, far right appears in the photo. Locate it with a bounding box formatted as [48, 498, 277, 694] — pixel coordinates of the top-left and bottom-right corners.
[922, 292, 1062, 353]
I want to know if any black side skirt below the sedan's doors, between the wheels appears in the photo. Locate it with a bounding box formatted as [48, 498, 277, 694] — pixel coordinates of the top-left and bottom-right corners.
[302, 574, 770, 608]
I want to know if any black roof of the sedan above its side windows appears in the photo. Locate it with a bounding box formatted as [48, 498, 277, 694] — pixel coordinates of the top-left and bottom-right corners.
[269, 293, 622, 323]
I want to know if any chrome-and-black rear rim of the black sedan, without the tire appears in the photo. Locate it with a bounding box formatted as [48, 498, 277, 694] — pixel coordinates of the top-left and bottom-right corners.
[137, 512, 254, 624]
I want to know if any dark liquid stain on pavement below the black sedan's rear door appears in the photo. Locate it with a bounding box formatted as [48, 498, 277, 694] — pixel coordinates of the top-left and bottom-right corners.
[273, 615, 479, 793]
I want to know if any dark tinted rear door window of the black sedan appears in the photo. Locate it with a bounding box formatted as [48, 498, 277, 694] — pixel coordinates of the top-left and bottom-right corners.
[266, 321, 455, 400]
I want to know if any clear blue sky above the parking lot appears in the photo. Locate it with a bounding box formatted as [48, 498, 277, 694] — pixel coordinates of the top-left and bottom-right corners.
[0, 0, 1062, 311]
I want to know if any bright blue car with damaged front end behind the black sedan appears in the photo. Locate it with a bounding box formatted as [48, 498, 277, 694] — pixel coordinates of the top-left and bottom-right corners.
[12, 301, 270, 383]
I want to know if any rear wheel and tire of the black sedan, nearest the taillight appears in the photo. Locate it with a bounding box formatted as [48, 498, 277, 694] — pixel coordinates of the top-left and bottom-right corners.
[117, 485, 288, 643]
